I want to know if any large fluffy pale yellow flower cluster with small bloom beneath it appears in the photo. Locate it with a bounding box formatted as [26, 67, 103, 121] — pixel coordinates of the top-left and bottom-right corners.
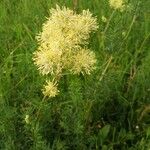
[33, 6, 98, 97]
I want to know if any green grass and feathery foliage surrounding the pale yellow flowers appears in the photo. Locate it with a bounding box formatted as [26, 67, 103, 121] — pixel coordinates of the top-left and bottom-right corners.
[0, 0, 150, 150]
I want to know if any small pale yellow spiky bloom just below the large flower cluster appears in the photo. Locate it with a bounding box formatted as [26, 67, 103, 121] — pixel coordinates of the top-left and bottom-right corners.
[43, 81, 59, 97]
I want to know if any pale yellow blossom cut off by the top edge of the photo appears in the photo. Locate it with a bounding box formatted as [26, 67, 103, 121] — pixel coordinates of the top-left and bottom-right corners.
[109, 0, 125, 11]
